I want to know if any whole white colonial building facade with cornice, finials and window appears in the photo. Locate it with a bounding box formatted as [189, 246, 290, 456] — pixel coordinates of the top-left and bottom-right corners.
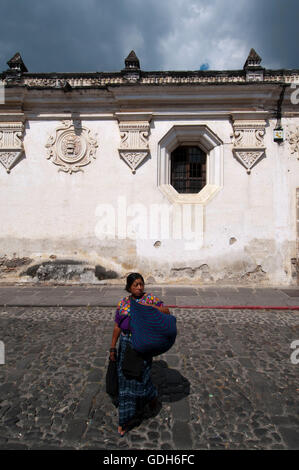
[0, 49, 299, 286]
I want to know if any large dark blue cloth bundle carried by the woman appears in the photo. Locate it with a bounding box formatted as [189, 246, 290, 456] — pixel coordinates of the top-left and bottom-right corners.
[130, 299, 177, 356]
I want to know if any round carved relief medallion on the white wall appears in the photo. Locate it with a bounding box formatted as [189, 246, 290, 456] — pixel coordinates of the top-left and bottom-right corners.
[46, 121, 98, 174]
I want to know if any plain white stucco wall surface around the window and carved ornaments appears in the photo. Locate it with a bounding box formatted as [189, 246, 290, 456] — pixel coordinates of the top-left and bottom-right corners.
[0, 111, 299, 285]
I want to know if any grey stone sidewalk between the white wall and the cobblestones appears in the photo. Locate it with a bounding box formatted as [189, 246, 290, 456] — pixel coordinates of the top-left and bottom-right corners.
[0, 284, 299, 308]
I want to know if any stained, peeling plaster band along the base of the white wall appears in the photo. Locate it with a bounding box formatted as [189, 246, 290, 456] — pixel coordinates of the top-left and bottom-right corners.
[0, 237, 297, 285]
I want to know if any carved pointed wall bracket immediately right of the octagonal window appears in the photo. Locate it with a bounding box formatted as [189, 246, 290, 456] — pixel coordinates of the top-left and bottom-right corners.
[233, 120, 266, 174]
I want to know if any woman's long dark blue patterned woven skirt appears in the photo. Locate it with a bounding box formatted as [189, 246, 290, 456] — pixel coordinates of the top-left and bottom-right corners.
[117, 334, 158, 427]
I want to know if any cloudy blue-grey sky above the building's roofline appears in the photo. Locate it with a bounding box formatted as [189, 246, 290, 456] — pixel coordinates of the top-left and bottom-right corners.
[0, 0, 299, 72]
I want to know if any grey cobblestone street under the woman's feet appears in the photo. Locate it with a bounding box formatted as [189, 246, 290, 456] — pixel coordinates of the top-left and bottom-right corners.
[0, 307, 299, 450]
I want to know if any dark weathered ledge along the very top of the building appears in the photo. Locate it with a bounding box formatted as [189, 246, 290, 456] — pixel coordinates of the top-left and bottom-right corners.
[0, 67, 299, 89]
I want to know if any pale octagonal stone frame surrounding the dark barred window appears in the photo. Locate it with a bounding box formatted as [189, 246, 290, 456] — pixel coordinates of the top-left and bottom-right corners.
[158, 124, 224, 205]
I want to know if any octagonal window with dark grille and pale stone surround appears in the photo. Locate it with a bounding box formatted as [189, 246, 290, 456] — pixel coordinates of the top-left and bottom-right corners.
[158, 124, 223, 205]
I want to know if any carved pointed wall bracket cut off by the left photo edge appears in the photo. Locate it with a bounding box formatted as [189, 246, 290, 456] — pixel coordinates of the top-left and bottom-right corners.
[0, 122, 24, 173]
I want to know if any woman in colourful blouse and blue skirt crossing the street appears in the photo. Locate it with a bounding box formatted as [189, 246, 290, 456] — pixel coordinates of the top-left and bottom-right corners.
[110, 273, 170, 436]
